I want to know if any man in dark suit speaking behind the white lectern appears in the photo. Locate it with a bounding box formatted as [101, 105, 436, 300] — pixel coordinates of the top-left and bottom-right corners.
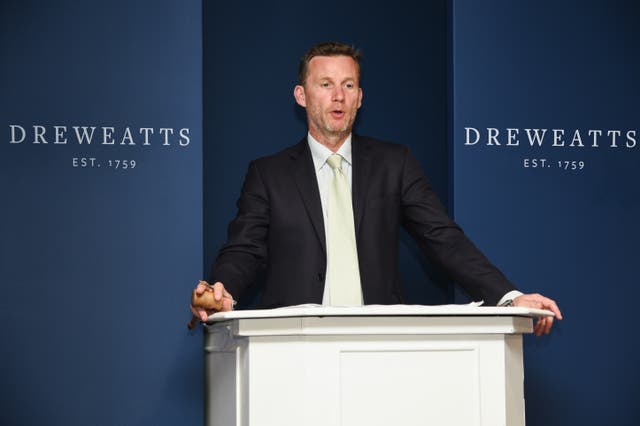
[191, 43, 562, 335]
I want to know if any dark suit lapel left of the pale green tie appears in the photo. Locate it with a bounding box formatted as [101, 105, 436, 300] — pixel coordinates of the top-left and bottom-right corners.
[290, 137, 327, 253]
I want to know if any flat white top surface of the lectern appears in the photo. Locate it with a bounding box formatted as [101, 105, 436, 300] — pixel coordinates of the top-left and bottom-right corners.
[207, 303, 553, 323]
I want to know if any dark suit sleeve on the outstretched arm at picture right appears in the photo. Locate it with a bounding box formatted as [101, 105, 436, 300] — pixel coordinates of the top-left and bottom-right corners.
[401, 149, 516, 305]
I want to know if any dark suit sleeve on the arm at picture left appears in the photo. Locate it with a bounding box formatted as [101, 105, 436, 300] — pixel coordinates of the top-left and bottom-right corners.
[210, 161, 269, 298]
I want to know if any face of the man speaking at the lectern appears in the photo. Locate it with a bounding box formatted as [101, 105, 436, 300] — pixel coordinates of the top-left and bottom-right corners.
[294, 56, 362, 143]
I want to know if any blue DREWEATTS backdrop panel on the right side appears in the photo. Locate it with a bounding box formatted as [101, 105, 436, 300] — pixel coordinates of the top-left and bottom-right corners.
[452, 0, 640, 426]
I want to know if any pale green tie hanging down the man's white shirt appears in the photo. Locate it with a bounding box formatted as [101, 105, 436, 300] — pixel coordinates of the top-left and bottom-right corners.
[327, 154, 362, 305]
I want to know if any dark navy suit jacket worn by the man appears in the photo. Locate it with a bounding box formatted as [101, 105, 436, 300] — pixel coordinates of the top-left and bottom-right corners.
[211, 135, 515, 308]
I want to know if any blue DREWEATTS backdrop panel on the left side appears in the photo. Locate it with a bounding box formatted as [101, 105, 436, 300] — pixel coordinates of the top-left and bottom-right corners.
[0, 0, 202, 426]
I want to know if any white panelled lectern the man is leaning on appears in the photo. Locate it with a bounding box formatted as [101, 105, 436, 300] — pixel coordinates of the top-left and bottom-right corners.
[205, 305, 551, 426]
